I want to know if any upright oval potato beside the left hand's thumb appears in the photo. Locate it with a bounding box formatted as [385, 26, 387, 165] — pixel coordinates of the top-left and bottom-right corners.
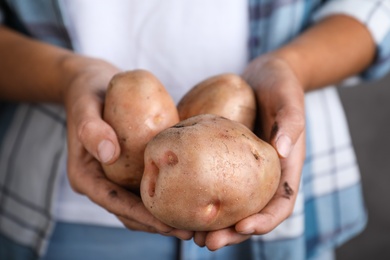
[102, 70, 179, 191]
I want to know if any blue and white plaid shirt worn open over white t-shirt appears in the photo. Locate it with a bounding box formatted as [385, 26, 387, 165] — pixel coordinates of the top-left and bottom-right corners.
[0, 0, 390, 259]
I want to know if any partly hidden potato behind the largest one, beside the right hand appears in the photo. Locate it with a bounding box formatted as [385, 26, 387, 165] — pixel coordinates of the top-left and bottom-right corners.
[177, 73, 256, 129]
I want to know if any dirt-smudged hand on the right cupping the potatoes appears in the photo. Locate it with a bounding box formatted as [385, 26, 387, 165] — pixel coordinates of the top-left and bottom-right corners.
[194, 54, 305, 250]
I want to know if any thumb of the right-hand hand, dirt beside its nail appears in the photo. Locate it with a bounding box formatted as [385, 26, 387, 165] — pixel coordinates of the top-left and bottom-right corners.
[271, 106, 305, 158]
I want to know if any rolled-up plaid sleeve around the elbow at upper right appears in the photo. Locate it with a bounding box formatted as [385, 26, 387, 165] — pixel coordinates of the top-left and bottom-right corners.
[313, 0, 390, 80]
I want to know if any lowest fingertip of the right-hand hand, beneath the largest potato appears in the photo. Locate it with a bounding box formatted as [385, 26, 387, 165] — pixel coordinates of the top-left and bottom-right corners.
[205, 227, 250, 251]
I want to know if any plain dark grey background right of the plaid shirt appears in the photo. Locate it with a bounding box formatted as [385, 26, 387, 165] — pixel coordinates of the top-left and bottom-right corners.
[336, 72, 390, 260]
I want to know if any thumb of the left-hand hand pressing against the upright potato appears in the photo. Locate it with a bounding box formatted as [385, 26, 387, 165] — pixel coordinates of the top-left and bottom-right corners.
[72, 92, 120, 164]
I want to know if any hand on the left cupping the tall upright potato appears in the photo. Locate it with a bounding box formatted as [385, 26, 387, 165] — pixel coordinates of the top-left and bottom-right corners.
[64, 60, 192, 239]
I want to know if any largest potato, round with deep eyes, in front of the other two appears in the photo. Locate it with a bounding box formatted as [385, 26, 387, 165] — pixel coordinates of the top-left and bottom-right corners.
[141, 114, 280, 231]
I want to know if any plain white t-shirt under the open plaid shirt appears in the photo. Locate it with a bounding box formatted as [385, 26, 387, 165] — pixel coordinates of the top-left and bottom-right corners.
[55, 0, 249, 226]
